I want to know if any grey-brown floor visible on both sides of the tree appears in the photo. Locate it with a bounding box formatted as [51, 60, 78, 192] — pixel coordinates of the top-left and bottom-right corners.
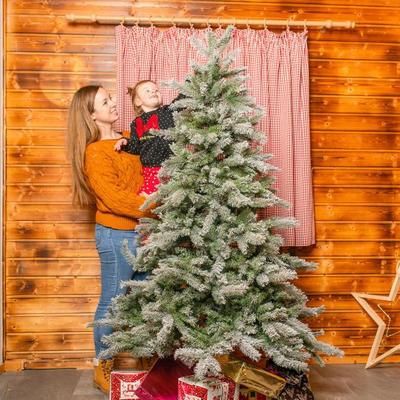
[0, 364, 400, 400]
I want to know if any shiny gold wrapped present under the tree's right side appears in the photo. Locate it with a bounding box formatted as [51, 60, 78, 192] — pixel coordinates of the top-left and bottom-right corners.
[221, 361, 286, 398]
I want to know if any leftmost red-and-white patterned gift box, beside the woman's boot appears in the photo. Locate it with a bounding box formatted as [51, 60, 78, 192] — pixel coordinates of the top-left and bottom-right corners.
[109, 371, 147, 400]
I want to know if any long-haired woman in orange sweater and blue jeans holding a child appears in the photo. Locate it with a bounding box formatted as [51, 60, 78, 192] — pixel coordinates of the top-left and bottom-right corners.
[68, 86, 149, 392]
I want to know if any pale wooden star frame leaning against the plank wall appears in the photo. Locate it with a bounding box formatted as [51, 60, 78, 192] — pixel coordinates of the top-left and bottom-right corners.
[352, 261, 400, 368]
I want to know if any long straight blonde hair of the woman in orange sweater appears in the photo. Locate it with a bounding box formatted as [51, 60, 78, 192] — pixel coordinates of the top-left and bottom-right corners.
[67, 85, 102, 206]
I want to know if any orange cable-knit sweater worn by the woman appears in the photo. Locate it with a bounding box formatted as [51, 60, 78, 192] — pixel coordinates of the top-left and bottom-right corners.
[85, 139, 150, 230]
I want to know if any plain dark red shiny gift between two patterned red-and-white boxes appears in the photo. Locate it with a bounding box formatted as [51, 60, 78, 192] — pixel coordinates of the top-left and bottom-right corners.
[136, 357, 193, 400]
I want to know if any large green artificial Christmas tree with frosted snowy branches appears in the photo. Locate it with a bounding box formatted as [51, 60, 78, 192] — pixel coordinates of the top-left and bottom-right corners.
[98, 28, 341, 379]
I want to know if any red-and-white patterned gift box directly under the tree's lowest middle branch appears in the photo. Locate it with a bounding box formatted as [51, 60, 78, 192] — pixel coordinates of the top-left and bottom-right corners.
[178, 376, 229, 400]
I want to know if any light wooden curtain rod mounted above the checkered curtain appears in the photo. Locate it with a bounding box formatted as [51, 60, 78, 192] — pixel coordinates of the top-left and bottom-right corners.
[66, 14, 356, 29]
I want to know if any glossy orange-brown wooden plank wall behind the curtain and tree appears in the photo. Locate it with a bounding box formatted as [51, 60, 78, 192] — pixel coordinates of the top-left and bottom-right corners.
[5, 0, 400, 369]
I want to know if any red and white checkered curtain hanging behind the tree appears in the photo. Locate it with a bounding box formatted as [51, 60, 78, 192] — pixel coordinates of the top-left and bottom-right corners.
[116, 25, 315, 246]
